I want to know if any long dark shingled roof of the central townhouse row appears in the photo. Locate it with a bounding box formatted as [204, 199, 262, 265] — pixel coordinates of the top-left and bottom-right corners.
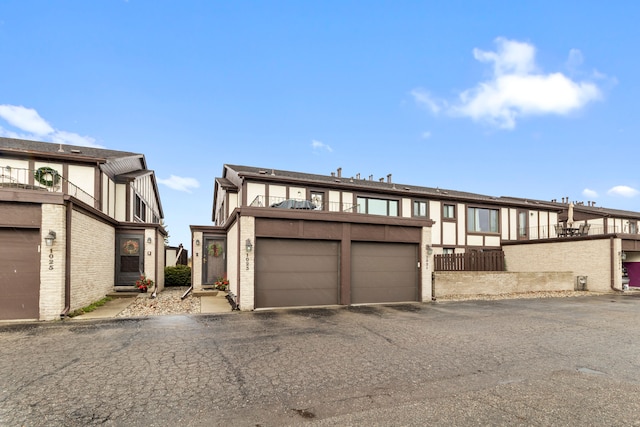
[223, 164, 561, 211]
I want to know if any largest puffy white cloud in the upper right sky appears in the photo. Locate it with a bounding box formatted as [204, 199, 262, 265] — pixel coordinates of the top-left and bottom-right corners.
[411, 38, 601, 129]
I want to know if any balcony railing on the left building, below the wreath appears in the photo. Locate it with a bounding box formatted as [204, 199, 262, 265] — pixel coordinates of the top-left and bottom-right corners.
[0, 166, 96, 206]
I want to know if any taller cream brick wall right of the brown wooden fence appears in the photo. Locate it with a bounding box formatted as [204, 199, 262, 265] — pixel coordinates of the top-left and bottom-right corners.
[503, 238, 622, 292]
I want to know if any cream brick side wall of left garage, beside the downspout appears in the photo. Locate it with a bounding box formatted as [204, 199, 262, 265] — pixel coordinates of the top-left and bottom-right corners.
[70, 210, 115, 311]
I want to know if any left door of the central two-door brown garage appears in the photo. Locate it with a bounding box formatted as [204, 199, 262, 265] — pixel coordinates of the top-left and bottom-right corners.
[255, 238, 339, 308]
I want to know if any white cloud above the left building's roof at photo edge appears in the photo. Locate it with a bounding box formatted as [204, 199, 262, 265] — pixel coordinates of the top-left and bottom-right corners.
[0, 104, 104, 148]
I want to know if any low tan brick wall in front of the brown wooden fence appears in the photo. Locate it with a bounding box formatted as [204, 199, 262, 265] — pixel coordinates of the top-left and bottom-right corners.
[435, 271, 574, 298]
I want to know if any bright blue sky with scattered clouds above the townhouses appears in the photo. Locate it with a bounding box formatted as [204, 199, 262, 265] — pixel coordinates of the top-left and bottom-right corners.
[0, 0, 640, 247]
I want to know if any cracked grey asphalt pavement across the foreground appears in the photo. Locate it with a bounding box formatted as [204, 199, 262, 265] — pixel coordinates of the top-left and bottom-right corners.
[0, 295, 640, 426]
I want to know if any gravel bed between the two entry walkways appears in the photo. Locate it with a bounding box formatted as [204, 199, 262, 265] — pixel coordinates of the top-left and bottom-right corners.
[117, 286, 200, 317]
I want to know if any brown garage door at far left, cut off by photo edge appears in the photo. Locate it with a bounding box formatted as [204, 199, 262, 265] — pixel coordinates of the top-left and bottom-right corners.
[0, 228, 40, 320]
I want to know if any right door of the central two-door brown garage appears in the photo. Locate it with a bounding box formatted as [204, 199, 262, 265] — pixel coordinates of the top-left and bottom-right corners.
[351, 242, 419, 304]
